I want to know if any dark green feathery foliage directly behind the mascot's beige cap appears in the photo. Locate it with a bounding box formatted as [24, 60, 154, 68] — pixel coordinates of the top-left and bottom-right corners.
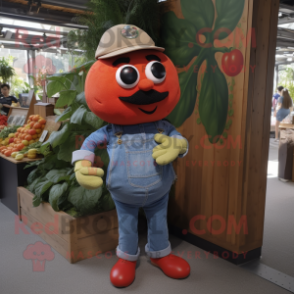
[68, 0, 160, 60]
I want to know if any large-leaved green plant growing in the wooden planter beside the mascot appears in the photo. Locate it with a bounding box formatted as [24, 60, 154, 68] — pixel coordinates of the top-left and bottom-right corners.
[27, 62, 114, 217]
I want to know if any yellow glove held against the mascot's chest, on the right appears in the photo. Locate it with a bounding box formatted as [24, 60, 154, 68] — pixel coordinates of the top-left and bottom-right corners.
[152, 134, 188, 165]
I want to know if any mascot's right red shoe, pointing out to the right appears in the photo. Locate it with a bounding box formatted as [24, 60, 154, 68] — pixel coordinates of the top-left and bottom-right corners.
[150, 254, 190, 279]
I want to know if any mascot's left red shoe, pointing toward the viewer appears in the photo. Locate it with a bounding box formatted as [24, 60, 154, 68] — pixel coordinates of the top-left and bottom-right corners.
[110, 258, 137, 288]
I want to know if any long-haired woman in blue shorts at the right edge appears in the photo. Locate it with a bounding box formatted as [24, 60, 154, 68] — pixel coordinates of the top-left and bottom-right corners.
[275, 89, 293, 142]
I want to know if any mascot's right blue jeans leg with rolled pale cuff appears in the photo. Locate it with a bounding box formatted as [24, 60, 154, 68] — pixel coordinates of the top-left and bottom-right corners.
[143, 193, 172, 258]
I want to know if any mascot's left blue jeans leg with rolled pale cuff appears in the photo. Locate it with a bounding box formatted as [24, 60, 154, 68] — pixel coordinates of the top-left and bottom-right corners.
[114, 200, 140, 261]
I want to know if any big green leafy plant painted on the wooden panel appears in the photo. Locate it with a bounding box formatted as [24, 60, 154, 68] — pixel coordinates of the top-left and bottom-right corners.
[161, 0, 245, 143]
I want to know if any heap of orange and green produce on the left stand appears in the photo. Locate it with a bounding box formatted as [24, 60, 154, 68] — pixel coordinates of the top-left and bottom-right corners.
[0, 115, 46, 160]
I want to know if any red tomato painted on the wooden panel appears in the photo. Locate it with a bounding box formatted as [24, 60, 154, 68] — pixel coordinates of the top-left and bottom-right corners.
[222, 49, 244, 77]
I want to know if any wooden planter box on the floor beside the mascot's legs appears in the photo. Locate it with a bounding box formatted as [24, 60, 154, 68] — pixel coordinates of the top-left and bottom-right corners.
[17, 187, 118, 263]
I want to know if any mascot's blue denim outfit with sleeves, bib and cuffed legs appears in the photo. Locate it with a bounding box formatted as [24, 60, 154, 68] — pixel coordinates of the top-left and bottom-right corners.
[73, 121, 187, 261]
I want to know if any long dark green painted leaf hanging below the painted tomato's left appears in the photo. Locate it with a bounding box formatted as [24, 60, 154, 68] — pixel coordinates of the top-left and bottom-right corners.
[199, 57, 229, 144]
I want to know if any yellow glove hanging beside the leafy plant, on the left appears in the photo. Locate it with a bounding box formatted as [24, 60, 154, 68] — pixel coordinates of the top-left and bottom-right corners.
[74, 160, 104, 190]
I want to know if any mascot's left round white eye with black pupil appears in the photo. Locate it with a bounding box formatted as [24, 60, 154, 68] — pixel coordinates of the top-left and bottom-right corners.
[116, 65, 140, 89]
